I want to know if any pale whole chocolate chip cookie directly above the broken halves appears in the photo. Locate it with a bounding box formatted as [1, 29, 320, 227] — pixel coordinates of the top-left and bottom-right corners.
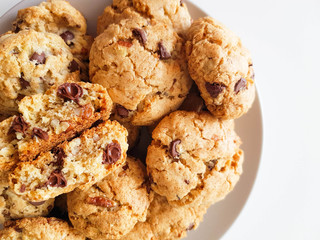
[0, 30, 73, 115]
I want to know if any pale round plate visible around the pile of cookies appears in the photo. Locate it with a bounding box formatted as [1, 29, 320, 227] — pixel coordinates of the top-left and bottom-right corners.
[0, 0, 263, 240]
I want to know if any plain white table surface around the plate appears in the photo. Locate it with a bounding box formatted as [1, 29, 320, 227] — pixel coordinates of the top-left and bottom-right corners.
[0, 0, 320, 240]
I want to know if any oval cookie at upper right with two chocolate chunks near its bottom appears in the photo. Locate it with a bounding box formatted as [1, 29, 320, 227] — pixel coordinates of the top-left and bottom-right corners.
[186, 17, 255, 119]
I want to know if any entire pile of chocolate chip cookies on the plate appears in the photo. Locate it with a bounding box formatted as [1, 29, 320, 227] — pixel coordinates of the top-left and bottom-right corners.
[0, 0, 255, 240]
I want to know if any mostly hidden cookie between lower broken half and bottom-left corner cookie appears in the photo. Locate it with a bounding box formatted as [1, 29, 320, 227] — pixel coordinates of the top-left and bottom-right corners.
[0, 187, 54, 224]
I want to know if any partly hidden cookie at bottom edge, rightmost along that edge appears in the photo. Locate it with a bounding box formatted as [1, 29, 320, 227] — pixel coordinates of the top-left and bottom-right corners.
[147, 194, 208, 240]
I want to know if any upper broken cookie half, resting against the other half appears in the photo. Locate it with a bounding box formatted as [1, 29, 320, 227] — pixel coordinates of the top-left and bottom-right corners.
[8, 82, 112, 161]
